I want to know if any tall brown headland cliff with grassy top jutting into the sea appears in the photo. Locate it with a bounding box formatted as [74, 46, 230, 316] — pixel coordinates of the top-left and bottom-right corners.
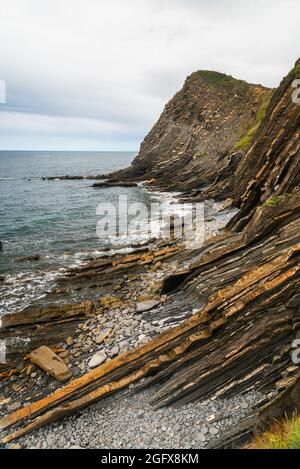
[110, 71, 270, 190]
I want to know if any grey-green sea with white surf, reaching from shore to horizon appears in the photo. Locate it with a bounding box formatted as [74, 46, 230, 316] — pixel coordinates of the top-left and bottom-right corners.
[0, 151, 176, 315]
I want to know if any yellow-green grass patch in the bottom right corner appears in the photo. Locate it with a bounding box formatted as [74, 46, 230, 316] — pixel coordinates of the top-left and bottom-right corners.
[249, 416, 300, 449]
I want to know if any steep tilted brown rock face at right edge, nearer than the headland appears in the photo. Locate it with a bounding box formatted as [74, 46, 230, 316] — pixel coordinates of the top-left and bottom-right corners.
[230, 60, 300, 230]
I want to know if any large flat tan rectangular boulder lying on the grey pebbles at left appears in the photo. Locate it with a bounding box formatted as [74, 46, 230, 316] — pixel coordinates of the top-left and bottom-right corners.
[29, 345, 72, 381]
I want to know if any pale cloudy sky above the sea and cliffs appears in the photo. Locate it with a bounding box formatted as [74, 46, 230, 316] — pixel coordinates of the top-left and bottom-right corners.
[0, 0, 300, 151]
